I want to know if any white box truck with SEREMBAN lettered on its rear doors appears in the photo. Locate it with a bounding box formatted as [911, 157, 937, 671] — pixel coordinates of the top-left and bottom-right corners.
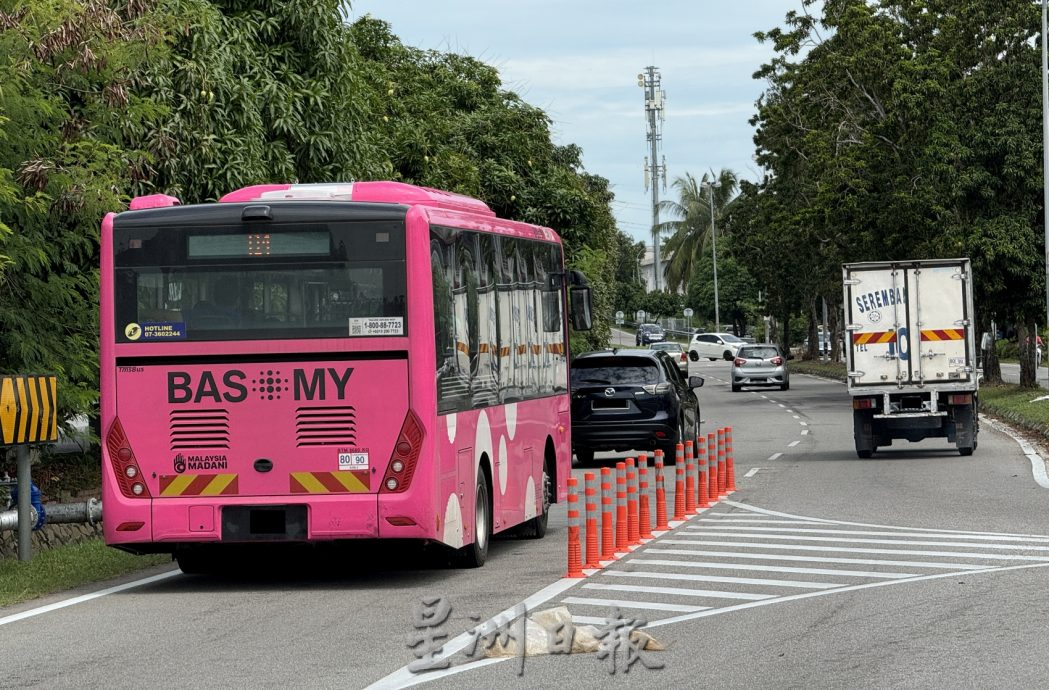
[842, 259, 980, 458]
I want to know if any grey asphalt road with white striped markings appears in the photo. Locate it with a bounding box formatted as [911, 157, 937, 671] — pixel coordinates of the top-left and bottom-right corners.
[0, 362, 1049, 688]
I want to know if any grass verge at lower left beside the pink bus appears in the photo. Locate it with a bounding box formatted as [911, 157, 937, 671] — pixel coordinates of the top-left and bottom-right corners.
[0, 539, 171, 606]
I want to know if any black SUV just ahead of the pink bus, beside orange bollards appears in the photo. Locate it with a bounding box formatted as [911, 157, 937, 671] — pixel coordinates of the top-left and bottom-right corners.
[571, 349, 703, 465]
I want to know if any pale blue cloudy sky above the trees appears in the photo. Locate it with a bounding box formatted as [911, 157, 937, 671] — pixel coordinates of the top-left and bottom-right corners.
[349, 0, 801, 243]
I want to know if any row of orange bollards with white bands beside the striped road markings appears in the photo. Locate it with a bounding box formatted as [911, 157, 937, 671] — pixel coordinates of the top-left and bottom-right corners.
[564, 427, 735, 578]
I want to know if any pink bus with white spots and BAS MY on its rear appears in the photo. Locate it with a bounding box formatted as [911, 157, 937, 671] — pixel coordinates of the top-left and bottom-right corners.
[100, 181, 591, 573]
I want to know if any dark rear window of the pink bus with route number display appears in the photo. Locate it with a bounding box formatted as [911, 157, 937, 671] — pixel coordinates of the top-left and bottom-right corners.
[113, 220, 407, 343]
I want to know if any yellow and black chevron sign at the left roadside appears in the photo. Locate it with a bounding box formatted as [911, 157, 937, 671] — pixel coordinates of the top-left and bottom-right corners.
[0, 376, 59, 446]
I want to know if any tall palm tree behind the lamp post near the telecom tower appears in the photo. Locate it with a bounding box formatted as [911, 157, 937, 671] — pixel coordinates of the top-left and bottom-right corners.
[654, 169, 738, 289]
